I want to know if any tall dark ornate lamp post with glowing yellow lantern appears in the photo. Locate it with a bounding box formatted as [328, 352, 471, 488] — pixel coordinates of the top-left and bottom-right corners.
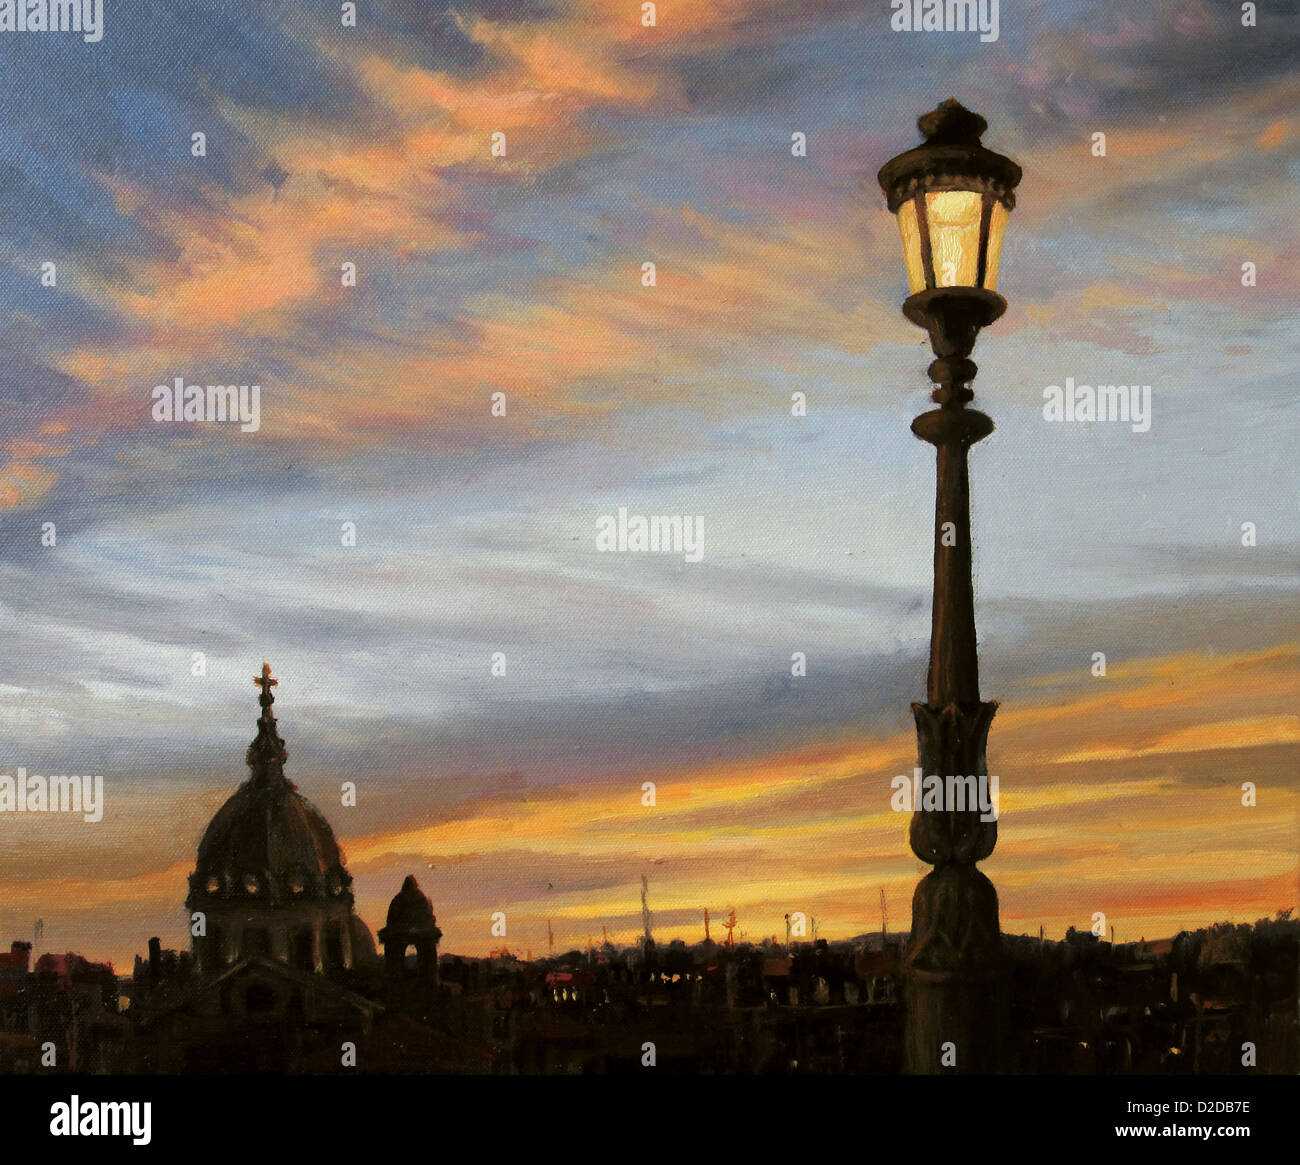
[878, 99, 1021, 1073]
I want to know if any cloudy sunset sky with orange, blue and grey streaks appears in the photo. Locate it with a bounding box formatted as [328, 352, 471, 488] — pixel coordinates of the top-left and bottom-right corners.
[0, 0, 1300, 970]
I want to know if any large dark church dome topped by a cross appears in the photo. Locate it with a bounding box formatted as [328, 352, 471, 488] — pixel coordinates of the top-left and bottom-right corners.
[190, 667, 352, 906]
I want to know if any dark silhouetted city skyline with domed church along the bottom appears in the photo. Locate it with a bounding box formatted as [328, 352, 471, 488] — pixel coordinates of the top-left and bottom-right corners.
[0, 668, 1300, 1074]
